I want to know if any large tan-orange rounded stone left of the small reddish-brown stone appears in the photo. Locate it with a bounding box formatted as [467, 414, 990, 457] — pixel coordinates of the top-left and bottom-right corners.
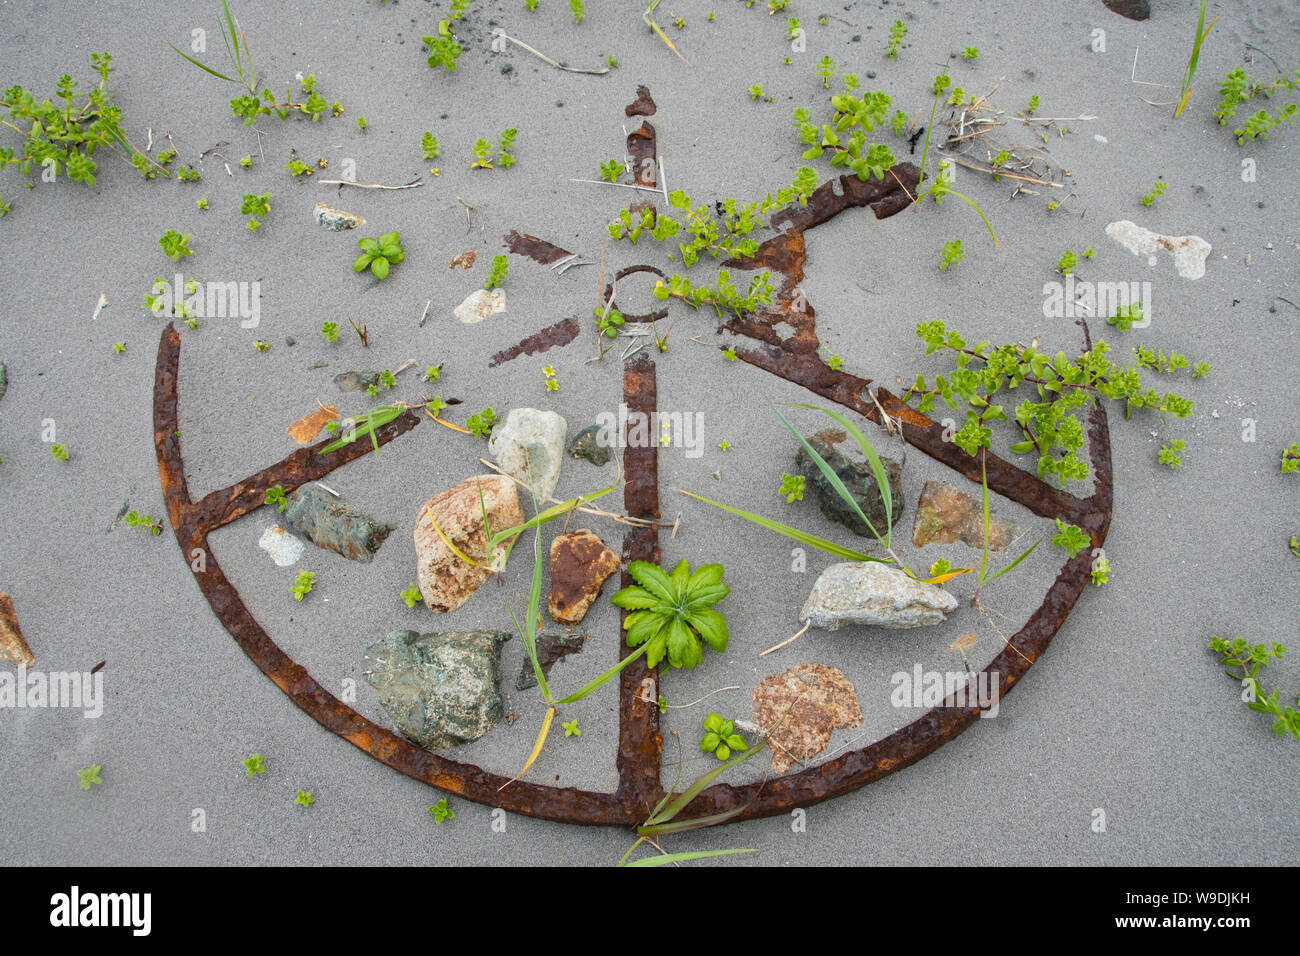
[415, 475, 524, 614]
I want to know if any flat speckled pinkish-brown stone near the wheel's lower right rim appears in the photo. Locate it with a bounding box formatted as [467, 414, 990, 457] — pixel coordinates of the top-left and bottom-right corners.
[753, 663, 862, 774]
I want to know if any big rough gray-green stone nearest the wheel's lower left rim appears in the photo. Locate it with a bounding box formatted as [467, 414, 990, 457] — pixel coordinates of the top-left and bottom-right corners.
[364, 631, 510, 750]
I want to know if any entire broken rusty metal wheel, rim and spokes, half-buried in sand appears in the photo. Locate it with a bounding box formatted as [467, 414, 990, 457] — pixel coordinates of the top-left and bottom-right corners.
[153, 94, 1112, 826]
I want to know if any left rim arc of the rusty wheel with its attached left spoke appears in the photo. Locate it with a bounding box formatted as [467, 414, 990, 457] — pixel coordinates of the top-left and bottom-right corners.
[153, 325, 634, 826]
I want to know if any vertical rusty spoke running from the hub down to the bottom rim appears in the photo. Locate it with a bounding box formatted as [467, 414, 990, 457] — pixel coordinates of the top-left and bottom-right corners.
[611, 352, 663, 823]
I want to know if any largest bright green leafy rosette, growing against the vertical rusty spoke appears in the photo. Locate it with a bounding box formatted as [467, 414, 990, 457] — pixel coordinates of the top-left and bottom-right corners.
[610, 561, 731, 670]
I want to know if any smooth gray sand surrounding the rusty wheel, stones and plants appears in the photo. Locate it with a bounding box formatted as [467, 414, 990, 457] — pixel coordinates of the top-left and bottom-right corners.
[0, 0, 1300, 865]
